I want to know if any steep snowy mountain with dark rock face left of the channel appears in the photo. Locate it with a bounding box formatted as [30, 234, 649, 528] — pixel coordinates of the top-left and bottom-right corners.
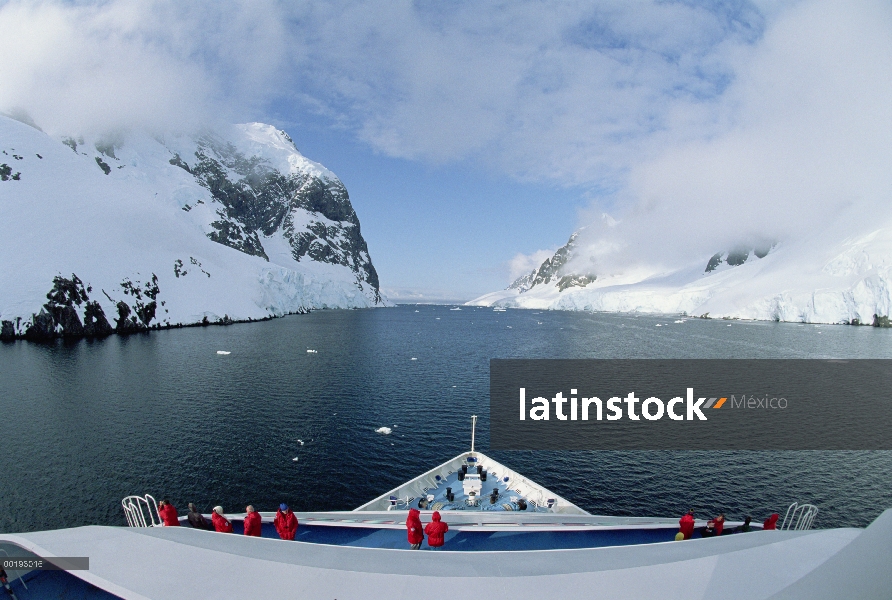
[0, 116, 383, 339]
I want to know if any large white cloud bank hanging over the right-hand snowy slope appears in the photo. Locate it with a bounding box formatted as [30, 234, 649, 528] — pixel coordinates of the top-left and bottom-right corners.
[583, 0, 892, 271]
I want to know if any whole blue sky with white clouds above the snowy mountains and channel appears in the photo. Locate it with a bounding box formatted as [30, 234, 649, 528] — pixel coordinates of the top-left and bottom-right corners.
[0, 0, 892, 300]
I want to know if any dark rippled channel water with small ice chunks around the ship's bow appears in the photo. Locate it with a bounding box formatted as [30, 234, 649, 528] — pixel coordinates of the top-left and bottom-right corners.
[0, 306, 892, 532]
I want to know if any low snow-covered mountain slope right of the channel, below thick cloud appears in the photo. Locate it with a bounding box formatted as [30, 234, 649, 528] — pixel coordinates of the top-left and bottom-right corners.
[468, 215, 892, 326]
